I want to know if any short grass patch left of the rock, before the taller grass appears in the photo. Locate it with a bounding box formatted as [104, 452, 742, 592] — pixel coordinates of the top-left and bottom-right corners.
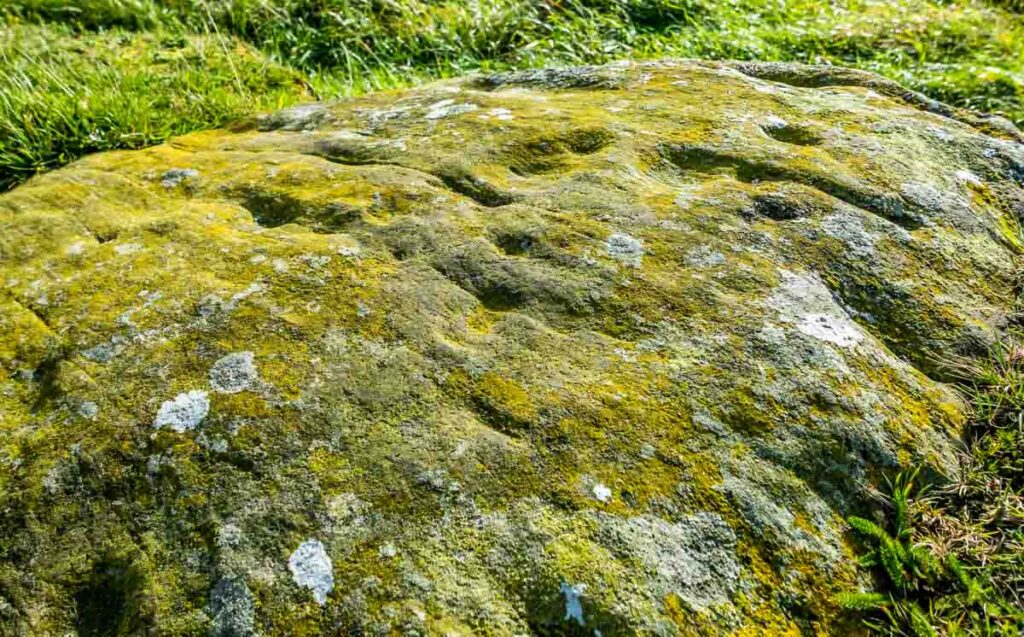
[0, 26, 309, 190]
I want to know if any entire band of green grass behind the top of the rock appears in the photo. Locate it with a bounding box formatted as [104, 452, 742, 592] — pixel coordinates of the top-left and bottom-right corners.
[0, 0, 1024, 189]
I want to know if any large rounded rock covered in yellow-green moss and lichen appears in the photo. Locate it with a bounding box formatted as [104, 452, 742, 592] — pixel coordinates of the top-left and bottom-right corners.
[0, 61, 1024, 636]
